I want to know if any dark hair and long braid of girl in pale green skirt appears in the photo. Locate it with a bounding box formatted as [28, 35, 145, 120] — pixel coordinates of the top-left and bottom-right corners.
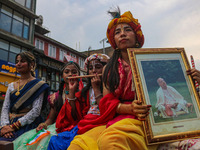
[54, 61, 80, 112]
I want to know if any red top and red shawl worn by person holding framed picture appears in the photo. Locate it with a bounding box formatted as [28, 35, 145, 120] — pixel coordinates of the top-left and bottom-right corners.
[78, 59, 136, 134]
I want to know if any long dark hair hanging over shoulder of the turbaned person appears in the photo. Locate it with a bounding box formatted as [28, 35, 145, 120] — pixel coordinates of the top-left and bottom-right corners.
[103, 49, 122, 93]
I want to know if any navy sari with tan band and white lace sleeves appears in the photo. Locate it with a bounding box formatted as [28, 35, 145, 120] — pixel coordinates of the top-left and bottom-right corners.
[0, 79, 49, 141]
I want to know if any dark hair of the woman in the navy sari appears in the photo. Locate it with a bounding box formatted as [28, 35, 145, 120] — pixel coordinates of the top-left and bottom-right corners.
[15, 51, 36, 77]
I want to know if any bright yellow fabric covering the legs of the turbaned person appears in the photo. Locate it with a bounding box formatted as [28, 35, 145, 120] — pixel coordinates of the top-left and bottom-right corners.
[68, 118, 147, 150]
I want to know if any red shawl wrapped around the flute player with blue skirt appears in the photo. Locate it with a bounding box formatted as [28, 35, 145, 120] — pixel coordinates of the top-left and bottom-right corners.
[56, 91, 90, 133]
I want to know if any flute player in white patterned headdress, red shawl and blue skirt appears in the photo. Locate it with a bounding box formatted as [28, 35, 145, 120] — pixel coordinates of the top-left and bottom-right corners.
[48, 54, 109, 150]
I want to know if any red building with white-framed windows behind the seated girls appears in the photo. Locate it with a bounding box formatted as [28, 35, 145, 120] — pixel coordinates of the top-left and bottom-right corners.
[34, 21, 87, 92]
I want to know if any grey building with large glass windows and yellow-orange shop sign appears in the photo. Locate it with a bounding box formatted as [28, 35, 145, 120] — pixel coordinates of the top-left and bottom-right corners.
[0, 0, 38, 99]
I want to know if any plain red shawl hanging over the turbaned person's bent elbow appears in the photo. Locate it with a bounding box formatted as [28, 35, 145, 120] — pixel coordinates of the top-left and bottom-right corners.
[78, 93, 120, 134]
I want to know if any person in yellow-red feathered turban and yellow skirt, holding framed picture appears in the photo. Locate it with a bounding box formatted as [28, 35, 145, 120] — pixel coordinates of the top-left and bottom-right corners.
[68, 7, 151, 150]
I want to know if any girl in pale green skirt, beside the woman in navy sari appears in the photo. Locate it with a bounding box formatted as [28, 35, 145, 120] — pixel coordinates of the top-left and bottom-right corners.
[14, 61, 80, 150]
